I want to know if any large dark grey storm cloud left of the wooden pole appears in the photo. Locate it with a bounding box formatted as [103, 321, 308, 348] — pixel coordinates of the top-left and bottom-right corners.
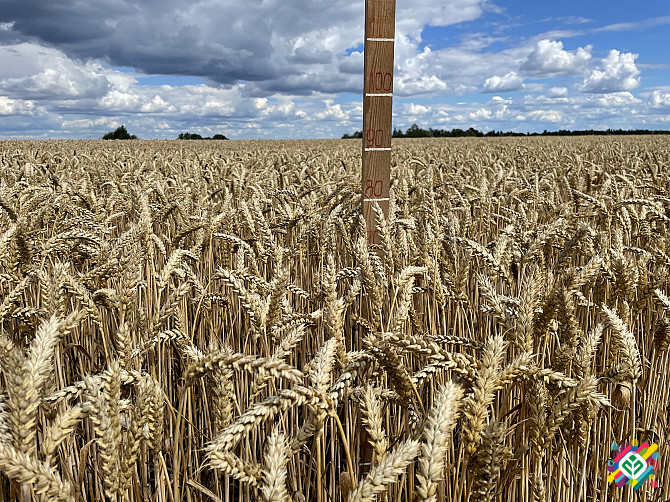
[0, 0, 362, 90]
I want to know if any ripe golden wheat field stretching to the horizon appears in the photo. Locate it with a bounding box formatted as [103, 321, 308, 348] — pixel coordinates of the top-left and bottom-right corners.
[0, 137, 670, 502]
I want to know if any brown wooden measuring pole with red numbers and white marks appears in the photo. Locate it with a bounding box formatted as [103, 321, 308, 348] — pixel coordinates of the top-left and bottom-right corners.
[362, 0, 396, 244]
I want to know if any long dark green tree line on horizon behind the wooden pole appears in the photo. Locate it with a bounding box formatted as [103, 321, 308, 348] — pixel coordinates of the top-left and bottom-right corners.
[342, 124, 670, 139]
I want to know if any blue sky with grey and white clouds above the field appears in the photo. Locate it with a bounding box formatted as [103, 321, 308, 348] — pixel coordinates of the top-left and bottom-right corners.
[0, 0, 670, 139]
